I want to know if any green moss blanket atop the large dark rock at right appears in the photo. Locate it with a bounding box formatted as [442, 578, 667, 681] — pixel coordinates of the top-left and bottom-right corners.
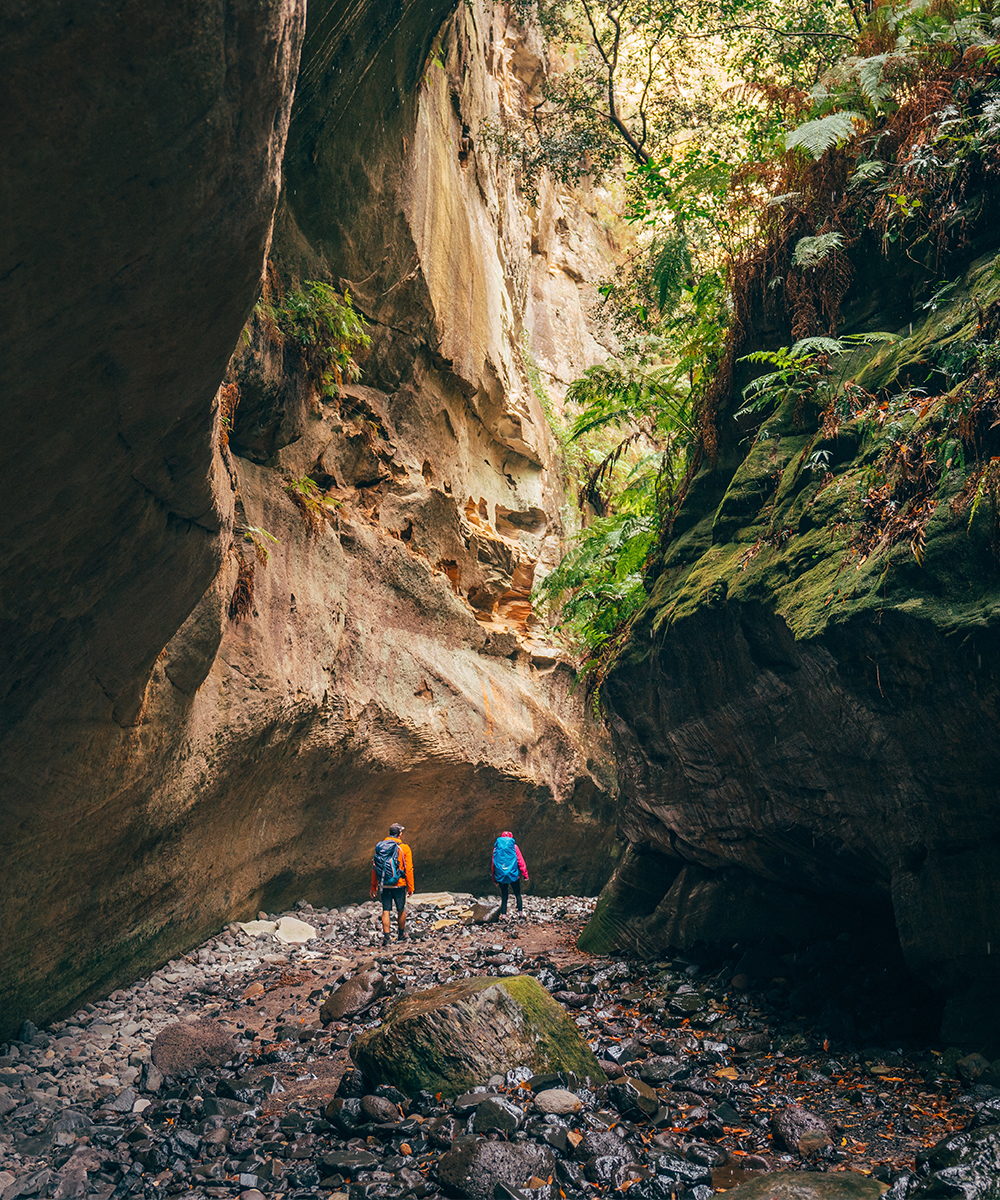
[623, 246, 1000, 662]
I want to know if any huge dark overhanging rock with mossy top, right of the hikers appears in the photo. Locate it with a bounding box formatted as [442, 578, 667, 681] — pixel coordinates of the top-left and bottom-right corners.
[581, 225, 1000, 1051]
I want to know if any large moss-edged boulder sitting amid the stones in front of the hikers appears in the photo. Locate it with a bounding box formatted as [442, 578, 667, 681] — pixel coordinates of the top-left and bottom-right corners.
[351, 976, 606, 1097]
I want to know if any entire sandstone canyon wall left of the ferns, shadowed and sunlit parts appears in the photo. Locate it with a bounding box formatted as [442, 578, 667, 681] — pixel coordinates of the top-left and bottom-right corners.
[0, 0, 612, 1036]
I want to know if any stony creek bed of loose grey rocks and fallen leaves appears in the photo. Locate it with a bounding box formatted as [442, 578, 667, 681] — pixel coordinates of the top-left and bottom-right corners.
[0, 894, 1000, 1200]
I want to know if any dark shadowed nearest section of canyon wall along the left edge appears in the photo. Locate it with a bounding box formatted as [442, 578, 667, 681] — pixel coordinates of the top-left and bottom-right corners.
[0, 0, 305, 1031]
